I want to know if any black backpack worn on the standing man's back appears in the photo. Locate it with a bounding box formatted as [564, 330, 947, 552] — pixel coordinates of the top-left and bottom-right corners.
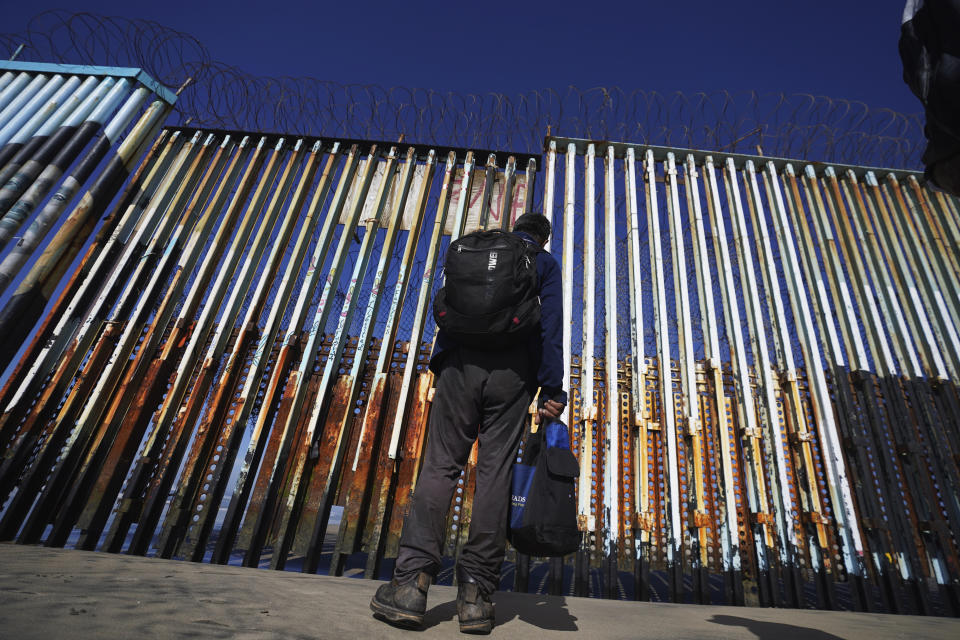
[433, 231, 540, 349]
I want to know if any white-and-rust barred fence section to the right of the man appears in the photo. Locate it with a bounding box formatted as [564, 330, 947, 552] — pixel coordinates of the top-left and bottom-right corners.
[544, 138, 960, 613]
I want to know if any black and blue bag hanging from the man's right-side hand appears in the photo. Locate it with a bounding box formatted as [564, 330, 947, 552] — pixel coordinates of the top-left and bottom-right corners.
[507, 420, 576, 557]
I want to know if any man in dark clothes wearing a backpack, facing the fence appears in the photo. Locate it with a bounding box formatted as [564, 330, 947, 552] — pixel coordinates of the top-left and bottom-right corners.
[370, 213, 567, 633]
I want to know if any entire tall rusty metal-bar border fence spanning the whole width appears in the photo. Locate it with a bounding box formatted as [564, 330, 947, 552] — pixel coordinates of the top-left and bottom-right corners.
[0, 51, 960, 615]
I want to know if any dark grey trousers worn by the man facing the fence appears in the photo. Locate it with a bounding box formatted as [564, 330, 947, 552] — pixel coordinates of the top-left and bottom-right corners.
[394, 346, 535, 593]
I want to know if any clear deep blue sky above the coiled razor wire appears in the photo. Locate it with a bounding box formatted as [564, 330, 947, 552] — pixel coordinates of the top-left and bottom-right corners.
[2, 0, 921, 113]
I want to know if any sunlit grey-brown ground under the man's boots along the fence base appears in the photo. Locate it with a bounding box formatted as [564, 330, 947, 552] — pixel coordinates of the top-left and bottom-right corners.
[0, 544, 960, 640]
